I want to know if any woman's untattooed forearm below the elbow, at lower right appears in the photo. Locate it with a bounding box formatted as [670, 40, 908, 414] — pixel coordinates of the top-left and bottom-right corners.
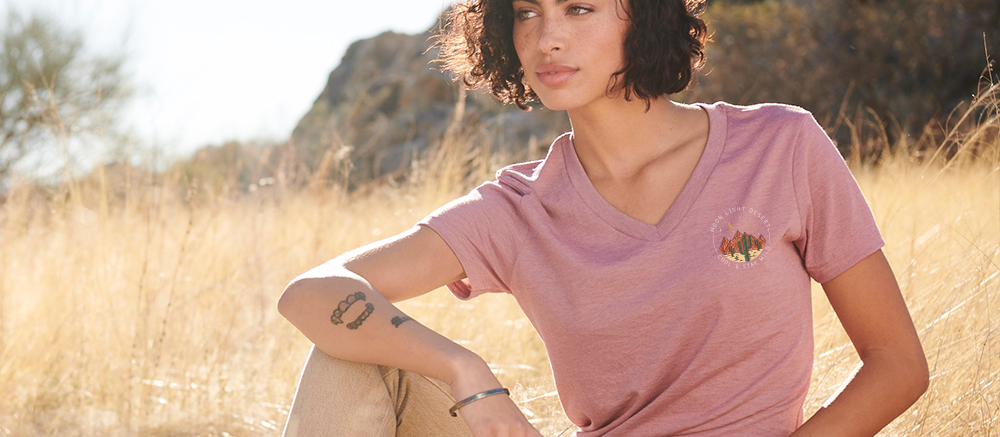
[792, 351, 927, 437]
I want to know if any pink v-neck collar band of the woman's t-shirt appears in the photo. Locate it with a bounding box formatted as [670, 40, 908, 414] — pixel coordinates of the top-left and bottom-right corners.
[562, 103, 726, 241]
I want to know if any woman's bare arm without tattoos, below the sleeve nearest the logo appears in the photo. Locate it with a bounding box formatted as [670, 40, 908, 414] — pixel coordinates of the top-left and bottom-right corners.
[792, 250, 928, 437]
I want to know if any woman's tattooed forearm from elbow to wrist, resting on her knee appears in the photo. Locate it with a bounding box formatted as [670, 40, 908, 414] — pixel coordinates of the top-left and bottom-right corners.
[278, 263, 496, 385]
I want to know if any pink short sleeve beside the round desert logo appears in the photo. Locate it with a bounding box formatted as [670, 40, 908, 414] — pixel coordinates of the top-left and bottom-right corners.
[793, 115, 885, 283]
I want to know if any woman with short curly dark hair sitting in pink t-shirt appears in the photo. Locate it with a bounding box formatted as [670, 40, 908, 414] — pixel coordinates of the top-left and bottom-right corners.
[278, 0, 928, 437]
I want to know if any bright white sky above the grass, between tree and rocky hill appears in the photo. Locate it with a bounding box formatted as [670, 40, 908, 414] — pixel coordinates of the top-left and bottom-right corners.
[0, 0, 451, 157]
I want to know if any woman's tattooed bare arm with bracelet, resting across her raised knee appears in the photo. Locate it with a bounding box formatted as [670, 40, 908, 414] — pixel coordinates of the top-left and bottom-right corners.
[278, 227, 538, 436]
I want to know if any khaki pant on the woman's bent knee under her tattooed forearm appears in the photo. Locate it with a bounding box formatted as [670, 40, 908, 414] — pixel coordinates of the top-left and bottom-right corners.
[284, 346, 472, 437]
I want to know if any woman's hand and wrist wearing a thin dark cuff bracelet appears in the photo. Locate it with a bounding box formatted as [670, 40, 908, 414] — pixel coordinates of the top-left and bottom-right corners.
[449, 354, 541, 437]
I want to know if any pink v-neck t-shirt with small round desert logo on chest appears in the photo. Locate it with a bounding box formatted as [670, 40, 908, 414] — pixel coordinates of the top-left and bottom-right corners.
[421, 103, 883, 437]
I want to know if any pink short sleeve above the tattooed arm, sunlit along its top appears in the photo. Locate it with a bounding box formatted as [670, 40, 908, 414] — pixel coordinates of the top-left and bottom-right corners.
[418, 182, 526, 299]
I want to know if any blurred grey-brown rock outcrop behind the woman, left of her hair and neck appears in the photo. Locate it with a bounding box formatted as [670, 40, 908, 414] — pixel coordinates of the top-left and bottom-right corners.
[290, 28, 569, 182]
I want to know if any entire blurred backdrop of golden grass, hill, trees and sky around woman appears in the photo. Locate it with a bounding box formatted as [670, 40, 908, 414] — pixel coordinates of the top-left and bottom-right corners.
[0, 0, 1000, 436]
